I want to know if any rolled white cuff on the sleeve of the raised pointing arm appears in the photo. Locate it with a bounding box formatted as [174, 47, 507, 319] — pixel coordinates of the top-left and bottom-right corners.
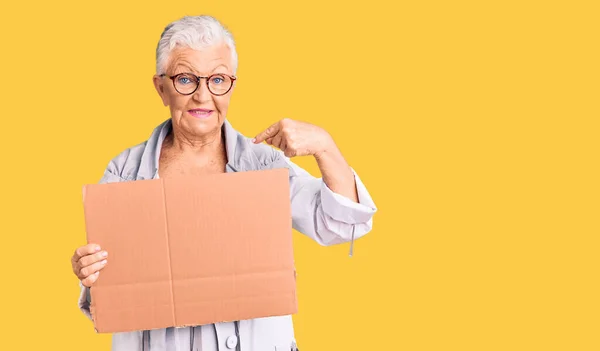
[321, 168, 377, 224]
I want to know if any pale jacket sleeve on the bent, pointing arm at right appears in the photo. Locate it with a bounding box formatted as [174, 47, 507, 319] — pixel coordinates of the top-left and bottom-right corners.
[280, 153, 377, 246]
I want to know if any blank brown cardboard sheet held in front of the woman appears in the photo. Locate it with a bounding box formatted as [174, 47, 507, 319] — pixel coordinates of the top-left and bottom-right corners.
[83, 169, 297, 333]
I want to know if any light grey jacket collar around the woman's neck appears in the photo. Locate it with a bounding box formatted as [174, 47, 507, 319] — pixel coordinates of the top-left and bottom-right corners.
[136, 118, 242, 180]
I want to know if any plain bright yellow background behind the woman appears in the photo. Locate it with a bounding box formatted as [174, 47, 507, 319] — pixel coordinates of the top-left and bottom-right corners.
[0, 0, 600, 351]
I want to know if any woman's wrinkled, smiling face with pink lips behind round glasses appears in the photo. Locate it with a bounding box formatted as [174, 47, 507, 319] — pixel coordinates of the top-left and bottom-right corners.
[153, 44, 235, 139]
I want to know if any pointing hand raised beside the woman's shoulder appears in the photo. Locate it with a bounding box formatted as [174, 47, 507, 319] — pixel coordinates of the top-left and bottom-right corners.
[253, 118, 335, 158]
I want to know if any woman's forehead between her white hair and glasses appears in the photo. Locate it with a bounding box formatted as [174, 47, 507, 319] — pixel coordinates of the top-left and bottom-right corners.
[167, 44, 232, 74]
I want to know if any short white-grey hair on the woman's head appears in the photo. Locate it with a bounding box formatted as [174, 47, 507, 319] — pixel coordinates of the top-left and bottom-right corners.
[156, 15, 238, 75]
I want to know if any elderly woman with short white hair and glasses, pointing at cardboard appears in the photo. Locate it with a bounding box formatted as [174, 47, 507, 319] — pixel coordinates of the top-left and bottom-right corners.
[71, 16, 376, 351]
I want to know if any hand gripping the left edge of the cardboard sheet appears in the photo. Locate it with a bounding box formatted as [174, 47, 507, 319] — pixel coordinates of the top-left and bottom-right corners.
[71, 244, 108, 288]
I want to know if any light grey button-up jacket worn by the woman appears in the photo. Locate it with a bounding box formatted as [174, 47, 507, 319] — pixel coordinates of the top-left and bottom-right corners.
[79, 119, 377, 351]
